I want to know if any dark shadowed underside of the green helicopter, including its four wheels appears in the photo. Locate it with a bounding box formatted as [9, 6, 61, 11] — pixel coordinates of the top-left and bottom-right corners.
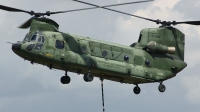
[13, 47, 170, 94]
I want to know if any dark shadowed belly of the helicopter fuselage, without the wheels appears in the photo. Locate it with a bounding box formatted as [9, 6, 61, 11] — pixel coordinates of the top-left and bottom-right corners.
[13, 46, 166, 85]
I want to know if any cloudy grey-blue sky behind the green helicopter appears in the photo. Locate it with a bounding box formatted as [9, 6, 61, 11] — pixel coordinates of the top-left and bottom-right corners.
[0, 0, 200, 112]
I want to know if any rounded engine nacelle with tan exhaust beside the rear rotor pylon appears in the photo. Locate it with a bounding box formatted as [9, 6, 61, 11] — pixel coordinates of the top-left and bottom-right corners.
[147, 41, 176, 54]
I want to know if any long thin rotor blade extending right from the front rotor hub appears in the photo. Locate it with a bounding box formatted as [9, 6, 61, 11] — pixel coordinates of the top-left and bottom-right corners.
[46, 0, 154, 14]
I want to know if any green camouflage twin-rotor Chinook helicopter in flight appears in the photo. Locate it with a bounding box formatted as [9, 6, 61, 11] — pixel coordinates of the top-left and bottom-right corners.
[0, 0, 200, 94]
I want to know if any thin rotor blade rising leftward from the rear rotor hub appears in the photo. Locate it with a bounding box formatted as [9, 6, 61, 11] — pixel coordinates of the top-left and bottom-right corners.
[73, 0, 160, 24]
